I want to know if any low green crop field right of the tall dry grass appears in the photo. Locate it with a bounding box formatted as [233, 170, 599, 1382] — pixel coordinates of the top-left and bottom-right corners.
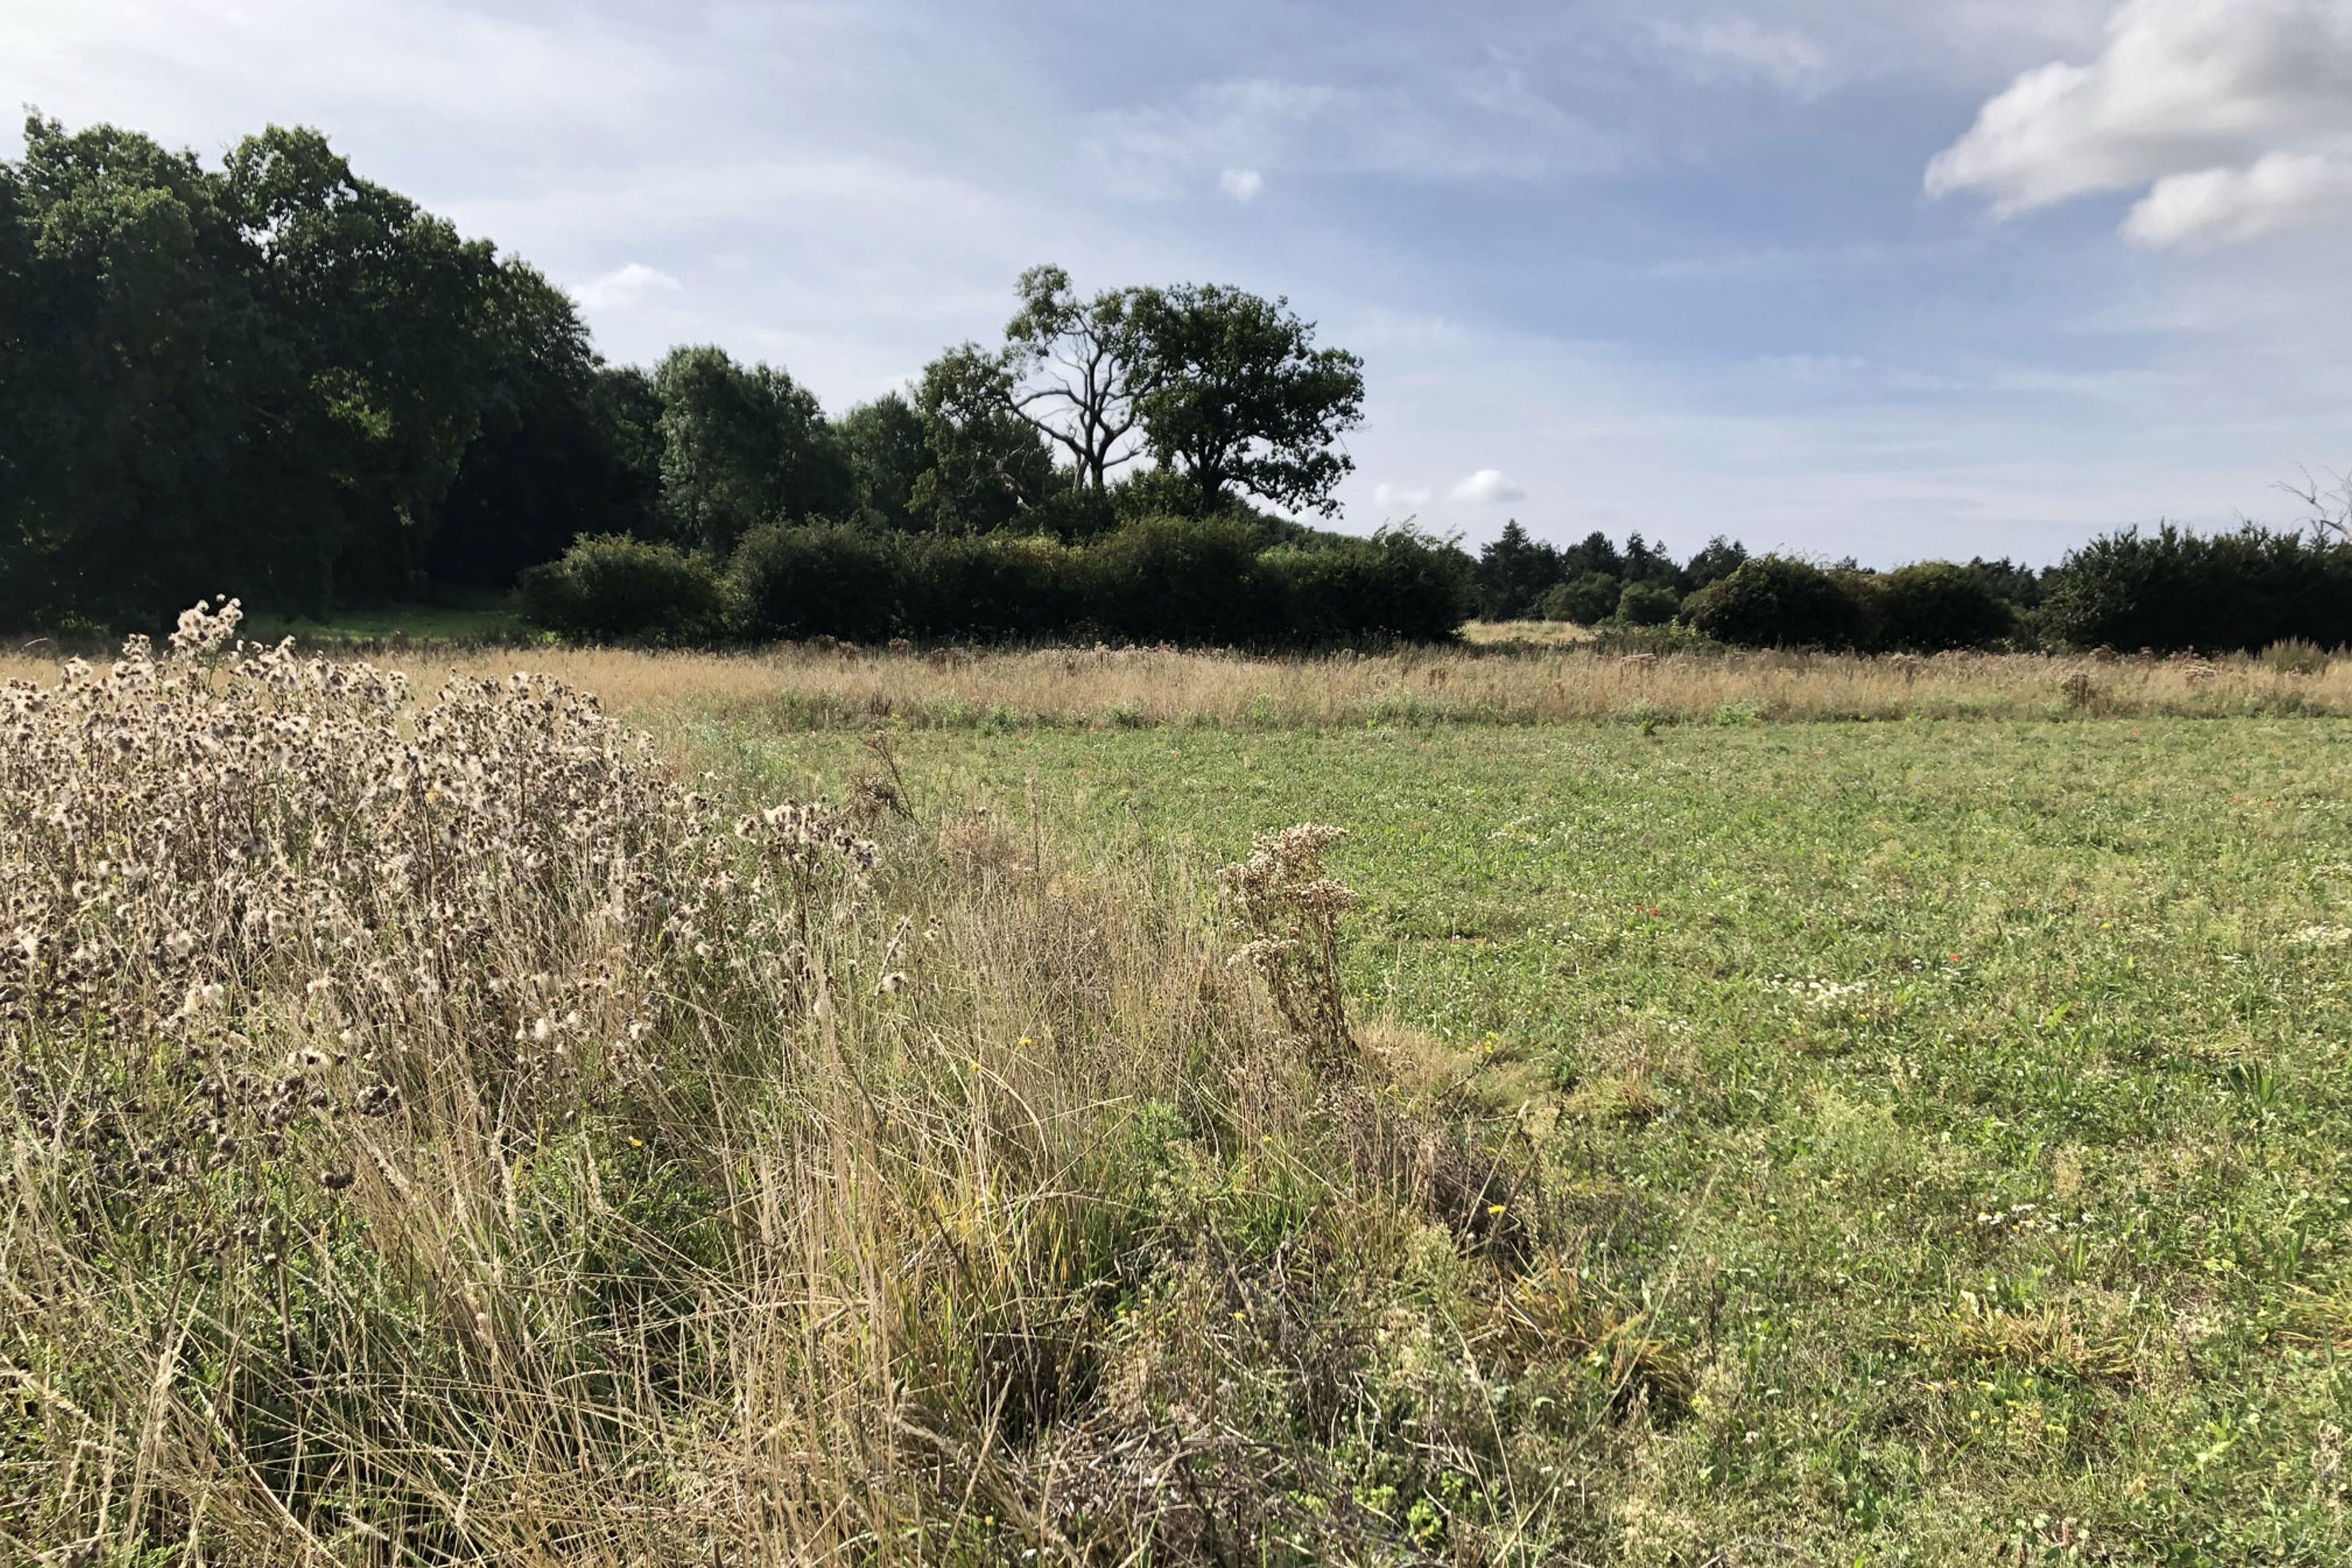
[701, 720, 2352, 1563]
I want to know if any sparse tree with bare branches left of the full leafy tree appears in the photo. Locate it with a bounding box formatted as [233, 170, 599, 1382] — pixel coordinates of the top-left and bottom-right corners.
[1004, 266, 1138, 493]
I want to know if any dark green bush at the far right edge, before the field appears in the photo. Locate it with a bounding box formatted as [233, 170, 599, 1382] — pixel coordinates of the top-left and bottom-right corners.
[2039, 525, 2352, 653]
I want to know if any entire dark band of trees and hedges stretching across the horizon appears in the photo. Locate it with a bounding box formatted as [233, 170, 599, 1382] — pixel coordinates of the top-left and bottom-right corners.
[0, 115, 2352, 651]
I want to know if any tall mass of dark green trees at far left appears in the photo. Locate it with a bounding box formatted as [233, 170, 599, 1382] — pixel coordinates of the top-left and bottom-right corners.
[0, 118, 607, 626]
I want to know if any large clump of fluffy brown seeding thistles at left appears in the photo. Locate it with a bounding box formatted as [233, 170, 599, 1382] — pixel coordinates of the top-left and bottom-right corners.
[0, 599, 875, 1142]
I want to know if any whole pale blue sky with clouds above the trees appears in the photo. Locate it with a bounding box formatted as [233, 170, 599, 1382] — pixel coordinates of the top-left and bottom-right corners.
[0, 0, 2352, 564]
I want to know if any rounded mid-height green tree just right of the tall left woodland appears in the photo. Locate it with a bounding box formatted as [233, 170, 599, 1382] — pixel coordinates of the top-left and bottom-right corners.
[653, 345, 854, 557]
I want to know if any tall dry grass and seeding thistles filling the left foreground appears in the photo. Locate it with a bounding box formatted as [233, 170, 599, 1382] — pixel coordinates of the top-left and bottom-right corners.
[0, 611, 1691, 1568]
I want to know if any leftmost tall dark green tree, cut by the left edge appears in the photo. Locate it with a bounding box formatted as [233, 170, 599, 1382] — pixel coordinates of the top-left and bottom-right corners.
[0, 115, 294, 623]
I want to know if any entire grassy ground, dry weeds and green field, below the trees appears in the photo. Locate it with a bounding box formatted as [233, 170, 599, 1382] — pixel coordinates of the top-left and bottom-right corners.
[0, 630, 2352, 1568]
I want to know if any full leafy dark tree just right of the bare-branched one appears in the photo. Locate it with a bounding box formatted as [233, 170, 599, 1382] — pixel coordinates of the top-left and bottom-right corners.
[1126, 284, 1364, 517]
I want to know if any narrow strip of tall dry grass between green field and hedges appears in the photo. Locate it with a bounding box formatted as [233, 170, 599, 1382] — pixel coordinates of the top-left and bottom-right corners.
[326, 646, 2352, 729]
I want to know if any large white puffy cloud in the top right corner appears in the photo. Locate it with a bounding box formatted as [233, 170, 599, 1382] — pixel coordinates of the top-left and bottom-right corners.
[1926, 0, 2352, 244]
